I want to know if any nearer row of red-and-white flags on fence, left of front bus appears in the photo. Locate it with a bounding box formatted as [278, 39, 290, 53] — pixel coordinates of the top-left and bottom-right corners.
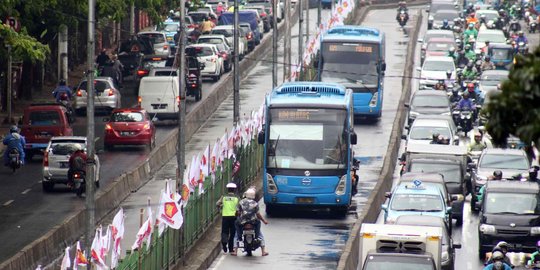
[47, 105, 264, 270]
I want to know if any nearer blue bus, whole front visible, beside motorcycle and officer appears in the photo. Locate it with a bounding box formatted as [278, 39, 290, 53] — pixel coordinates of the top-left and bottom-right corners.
[258, 82, 357, 215]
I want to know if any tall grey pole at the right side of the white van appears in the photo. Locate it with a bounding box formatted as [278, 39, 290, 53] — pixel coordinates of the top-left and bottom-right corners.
[176, 0, 186, 190]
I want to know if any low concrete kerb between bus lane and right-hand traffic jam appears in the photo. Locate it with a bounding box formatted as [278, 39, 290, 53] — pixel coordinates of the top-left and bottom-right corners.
[337, 6, 427, 270]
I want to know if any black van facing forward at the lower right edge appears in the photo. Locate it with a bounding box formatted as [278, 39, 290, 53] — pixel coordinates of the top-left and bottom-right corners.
[478, 180, 540, 259]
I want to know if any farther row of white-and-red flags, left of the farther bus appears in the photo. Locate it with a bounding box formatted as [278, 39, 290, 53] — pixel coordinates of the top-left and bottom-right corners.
[289, 0, 355, 81]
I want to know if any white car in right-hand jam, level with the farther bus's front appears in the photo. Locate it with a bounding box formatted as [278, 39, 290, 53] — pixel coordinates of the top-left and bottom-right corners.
[416, 56, 456, 89]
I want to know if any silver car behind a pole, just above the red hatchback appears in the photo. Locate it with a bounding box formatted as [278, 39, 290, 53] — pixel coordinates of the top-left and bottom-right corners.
[73, 77, 122, 114]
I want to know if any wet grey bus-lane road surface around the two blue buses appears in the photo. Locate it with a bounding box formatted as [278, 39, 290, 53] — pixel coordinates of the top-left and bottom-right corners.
[205, 8, 416, 270]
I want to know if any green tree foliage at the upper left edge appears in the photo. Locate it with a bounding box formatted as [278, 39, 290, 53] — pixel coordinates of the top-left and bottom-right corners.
[0, 24, 50, 62]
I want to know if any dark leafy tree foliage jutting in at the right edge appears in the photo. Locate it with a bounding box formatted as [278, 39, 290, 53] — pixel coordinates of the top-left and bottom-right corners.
[486, 47, 540, 146]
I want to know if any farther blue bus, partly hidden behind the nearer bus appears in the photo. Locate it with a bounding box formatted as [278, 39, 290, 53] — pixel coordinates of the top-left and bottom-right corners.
[317, 25, 386, 118]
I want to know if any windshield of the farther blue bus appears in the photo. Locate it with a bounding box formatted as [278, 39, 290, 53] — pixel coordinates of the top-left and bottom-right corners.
[321, 42, 380, 85]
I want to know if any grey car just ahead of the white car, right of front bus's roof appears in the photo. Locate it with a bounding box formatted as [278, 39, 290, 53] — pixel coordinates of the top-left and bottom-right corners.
[404, 90, 450, 126]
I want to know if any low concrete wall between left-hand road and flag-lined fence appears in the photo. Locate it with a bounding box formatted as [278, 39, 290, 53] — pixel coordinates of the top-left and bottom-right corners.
[0, 4, 298, 270]
